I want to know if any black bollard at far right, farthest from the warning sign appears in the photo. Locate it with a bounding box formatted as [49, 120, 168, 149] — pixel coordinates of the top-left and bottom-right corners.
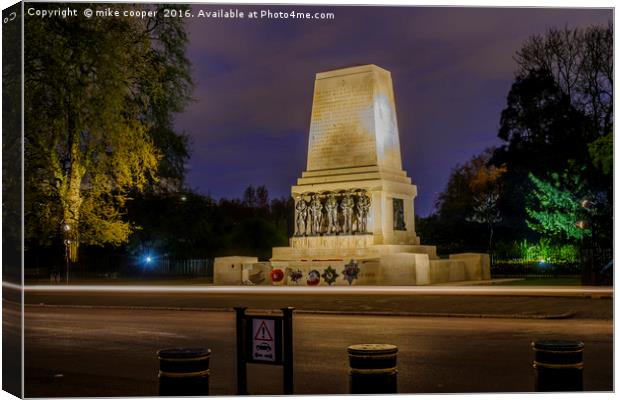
[532, 340, 583, 392]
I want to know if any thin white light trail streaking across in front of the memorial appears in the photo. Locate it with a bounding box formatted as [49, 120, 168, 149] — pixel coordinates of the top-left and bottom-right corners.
[10, 282, 613, 297]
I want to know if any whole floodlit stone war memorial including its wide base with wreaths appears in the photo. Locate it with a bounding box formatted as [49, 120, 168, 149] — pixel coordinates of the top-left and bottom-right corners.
[214, 64, 490, 286]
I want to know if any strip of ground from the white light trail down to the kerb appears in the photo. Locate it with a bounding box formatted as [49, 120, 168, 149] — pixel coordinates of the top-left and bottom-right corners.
[25, 285, 613, 320]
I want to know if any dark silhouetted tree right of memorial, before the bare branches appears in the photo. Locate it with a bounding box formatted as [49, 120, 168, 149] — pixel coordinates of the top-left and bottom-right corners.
[491, 70, 596, 240]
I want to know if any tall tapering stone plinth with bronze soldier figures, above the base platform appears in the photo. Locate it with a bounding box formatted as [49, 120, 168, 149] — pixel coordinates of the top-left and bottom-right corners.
[273, 65, 418, 260]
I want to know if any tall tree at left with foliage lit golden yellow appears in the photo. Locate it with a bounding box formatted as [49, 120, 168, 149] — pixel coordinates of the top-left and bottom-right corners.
[24, 4, 192, 260]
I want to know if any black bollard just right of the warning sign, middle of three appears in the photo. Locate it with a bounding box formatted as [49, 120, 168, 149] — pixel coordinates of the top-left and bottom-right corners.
[347, 344, 398, 394]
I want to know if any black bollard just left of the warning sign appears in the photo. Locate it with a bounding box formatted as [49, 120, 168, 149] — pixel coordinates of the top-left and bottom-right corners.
[157, 348, 211, 396]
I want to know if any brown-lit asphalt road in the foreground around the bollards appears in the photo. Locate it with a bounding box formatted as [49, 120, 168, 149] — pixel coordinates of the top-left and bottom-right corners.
[25, 304, 613, 397]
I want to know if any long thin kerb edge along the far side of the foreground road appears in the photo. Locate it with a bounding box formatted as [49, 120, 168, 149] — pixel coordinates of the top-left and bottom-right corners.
[24, 303, 575, 319]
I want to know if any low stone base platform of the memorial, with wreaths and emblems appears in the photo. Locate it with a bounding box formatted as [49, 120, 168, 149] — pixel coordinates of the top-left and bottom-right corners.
[214, 252, 490, 286]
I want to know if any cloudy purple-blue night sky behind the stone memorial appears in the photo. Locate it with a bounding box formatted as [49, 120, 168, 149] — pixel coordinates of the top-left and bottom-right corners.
[176, 5, 612, 216]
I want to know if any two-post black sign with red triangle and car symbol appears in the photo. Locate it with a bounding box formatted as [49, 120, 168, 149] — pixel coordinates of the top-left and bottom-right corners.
[235, 307, 295, 395]
